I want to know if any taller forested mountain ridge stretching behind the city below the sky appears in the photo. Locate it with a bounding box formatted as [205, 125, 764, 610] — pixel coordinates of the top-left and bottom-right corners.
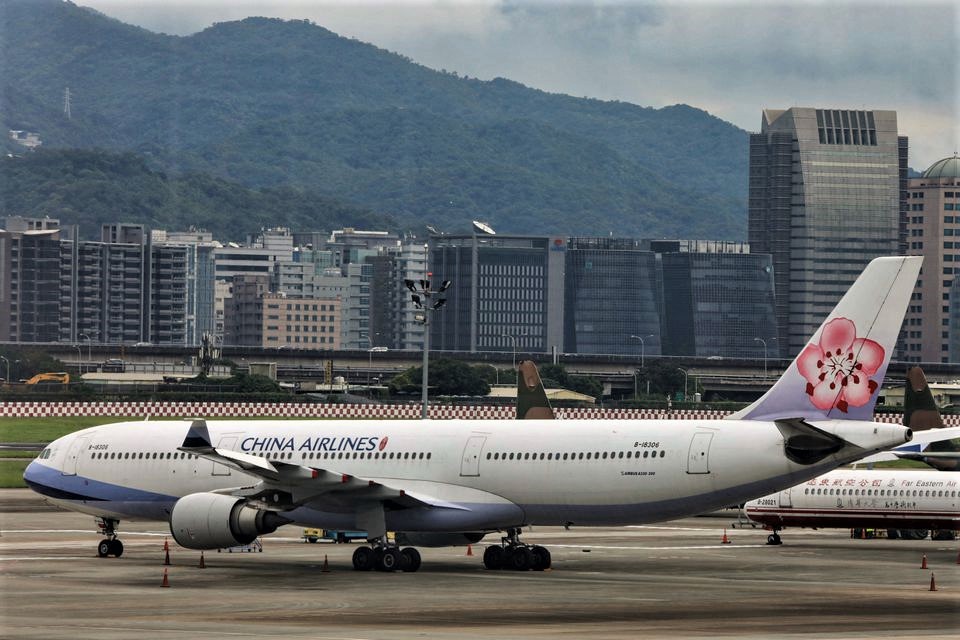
[0, 0, 748, 239]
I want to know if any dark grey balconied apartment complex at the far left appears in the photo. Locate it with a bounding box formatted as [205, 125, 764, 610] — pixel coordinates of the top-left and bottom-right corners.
[0, 219, 190, 344]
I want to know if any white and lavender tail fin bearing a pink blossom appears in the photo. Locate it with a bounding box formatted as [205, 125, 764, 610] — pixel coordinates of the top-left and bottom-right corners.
[728, 256, 923, 421]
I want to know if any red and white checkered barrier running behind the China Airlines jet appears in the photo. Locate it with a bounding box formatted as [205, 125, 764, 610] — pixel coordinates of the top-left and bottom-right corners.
[0, 402, 960, 427]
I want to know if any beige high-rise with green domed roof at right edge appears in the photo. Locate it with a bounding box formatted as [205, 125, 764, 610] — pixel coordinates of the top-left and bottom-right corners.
[904, 155, 960, 362]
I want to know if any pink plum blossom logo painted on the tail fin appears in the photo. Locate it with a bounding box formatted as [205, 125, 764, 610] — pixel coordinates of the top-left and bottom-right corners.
[797, 318, 885, 413]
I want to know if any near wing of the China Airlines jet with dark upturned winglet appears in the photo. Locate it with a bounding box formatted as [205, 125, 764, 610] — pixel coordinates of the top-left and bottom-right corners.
[178, 420, 466, 511]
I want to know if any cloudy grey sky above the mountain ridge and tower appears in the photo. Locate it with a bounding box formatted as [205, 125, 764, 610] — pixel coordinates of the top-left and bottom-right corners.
[80, 0, 960, 170]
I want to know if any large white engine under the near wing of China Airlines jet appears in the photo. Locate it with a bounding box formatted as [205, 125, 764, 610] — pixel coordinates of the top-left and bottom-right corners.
[170, 493, 290, 550]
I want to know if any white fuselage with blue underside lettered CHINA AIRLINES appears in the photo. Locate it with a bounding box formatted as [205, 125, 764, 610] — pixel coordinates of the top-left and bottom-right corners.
[25, 420, 909, 531]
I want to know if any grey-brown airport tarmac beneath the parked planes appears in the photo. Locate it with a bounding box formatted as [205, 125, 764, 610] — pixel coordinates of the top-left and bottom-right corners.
[0, 489, 960, 640]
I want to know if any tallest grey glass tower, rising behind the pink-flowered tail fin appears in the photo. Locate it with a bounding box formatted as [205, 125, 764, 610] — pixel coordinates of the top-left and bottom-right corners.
[749, 107, 907, 354]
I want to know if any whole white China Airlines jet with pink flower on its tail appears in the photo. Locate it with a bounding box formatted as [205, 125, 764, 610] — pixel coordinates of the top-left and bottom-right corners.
[24, 257, 921, 571]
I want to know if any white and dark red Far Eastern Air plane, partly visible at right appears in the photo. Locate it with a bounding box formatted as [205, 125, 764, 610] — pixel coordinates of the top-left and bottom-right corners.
[743, 469, 960, 544]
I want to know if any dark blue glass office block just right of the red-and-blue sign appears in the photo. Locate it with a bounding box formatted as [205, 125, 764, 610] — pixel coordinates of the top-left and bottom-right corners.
[563, 238, 661, 356]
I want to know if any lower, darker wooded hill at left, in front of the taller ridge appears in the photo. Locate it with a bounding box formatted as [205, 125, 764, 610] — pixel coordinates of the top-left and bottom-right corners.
[0, 149, 397, 239]
